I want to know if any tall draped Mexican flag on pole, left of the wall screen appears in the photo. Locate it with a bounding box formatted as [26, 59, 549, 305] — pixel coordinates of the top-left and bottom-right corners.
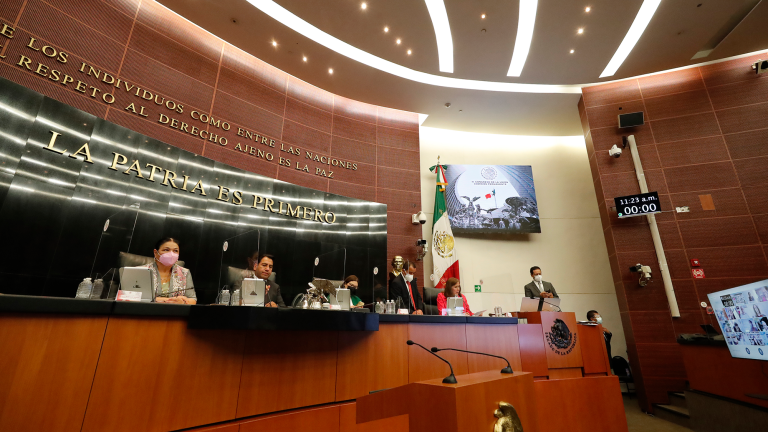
[429, 164, 459, 288]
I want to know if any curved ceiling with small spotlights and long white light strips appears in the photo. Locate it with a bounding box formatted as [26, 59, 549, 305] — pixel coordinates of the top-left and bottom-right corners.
[160, 0, 768, 135]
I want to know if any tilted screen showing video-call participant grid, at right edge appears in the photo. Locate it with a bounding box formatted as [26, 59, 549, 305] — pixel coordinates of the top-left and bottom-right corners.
[707, 279, 768, 360]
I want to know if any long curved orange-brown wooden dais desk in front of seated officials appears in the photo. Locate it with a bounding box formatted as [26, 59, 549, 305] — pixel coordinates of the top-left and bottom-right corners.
[0, 299, 623, 432]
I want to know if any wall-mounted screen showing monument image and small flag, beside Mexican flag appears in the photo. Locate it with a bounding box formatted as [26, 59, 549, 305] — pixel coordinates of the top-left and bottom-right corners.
[445, 165, 541, 234]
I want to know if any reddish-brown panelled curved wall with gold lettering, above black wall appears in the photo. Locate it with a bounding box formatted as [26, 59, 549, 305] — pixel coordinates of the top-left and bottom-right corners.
[0, 0, 424, 286]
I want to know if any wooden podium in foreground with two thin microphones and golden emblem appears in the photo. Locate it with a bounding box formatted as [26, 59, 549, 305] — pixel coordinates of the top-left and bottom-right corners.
[357, 371, 538, 432]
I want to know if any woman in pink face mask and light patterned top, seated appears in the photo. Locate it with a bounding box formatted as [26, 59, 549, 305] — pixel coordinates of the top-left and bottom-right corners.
[144, 237, 197, 304]
